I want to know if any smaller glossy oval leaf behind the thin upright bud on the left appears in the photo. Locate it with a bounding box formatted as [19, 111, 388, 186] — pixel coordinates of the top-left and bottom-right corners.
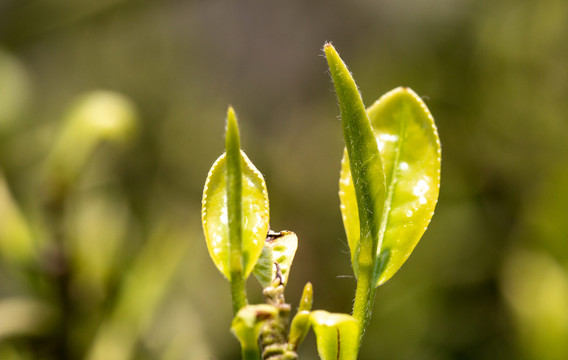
[201, 151, 269, 279]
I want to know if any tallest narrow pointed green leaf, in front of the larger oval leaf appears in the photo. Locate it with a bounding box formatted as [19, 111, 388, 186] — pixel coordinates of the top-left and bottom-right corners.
[324, 43, 385, 275]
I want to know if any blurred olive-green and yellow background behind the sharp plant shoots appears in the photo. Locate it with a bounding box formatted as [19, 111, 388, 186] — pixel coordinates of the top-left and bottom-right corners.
[0, 0, 568, 360]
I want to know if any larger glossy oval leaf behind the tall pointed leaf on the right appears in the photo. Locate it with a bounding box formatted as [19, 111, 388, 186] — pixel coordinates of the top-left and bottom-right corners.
[339, 87, 441, 286]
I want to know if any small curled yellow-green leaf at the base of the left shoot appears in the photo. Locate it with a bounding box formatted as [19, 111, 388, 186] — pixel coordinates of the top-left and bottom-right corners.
[231, 304, 278, 360]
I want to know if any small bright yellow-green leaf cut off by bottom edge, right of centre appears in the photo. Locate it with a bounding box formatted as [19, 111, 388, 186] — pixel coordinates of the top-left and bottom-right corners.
[310, 310, 359, 360]
